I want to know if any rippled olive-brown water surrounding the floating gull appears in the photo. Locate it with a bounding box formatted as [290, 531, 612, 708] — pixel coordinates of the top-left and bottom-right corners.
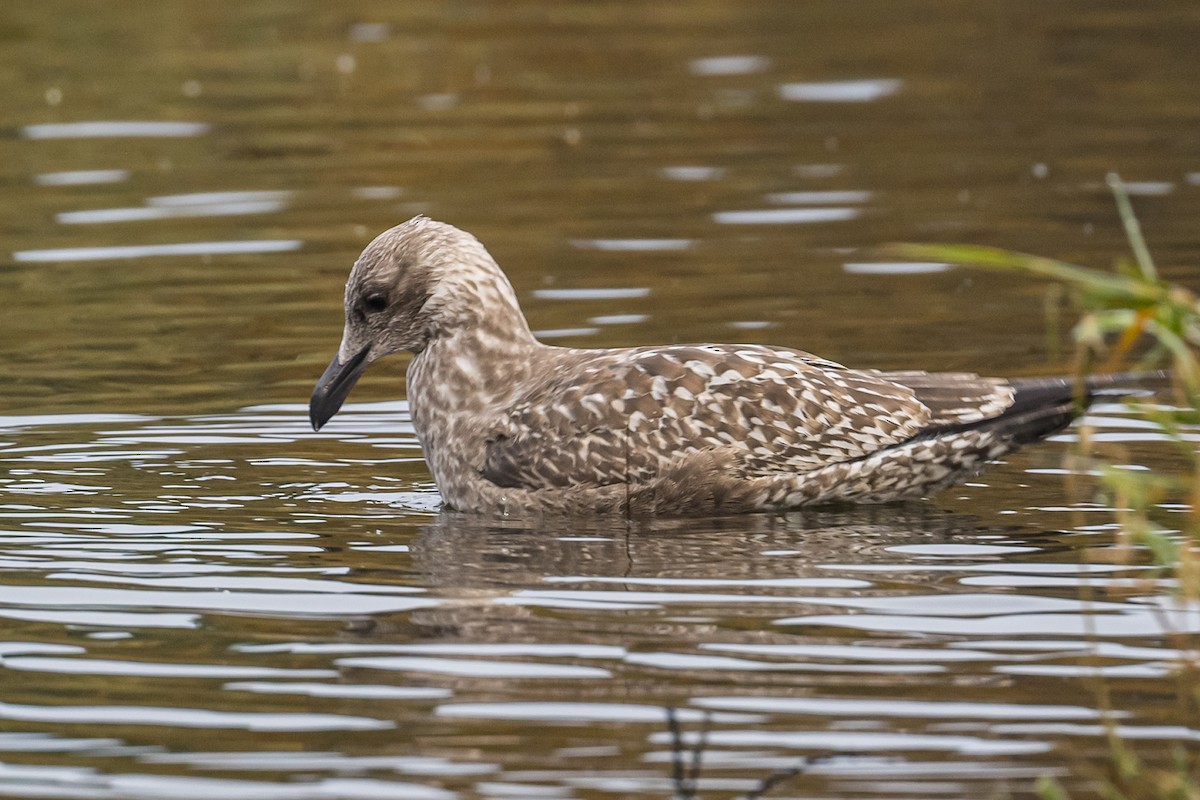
[0, 0, 1200, 800]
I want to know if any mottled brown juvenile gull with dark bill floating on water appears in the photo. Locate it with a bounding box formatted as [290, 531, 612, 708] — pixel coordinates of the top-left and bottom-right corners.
[310, 217, 1147, 516]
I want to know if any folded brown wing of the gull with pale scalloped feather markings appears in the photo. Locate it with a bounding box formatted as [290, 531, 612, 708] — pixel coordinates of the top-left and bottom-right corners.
[481, 344, 1013, 489]
